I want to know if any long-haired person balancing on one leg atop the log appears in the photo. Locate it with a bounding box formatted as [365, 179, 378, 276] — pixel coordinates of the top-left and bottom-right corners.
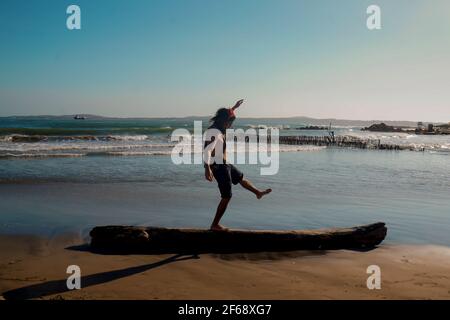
[204, 100, 272, 231]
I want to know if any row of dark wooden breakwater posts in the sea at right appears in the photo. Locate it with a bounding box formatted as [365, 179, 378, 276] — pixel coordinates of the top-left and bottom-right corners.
[279, 136, 407, 150]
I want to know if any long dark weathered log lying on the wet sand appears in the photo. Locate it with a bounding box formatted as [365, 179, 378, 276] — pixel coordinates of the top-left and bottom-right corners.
[90, 222, 387, 253]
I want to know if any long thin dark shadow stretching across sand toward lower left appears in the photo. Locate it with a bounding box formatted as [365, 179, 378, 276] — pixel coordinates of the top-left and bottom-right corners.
[3, 252, 199, 300]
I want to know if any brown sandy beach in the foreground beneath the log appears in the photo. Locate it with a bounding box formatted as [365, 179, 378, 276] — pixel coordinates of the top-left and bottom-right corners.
[0, 235, 450, 299]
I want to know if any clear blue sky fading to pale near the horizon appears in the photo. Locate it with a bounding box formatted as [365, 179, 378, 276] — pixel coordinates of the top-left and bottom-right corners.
[0, 0, 450, 121]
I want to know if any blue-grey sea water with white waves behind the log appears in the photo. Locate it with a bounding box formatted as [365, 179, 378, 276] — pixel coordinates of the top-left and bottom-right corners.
[0, 119, 450, 245]
